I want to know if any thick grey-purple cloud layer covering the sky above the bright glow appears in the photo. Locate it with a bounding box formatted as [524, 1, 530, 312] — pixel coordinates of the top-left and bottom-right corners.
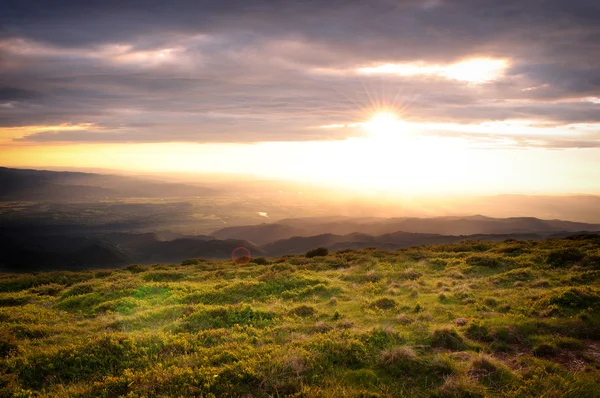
[0, 0, 600, 145]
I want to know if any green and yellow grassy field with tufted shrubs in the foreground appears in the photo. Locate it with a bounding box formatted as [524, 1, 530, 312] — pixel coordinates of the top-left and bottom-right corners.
[0, 235, 600, 397]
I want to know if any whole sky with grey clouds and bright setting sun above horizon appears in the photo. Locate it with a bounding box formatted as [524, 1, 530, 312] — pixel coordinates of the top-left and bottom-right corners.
[0, 0, 600, 194]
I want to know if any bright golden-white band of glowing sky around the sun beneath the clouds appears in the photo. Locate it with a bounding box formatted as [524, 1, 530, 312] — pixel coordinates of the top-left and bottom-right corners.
[0, 110, 600, 195]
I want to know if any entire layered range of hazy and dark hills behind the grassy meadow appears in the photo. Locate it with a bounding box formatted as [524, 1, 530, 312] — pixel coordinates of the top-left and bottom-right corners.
[0, 216, 600, 271]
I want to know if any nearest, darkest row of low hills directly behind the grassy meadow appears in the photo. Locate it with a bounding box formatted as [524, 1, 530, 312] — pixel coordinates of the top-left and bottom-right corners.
[0, 225, 591, 272]
